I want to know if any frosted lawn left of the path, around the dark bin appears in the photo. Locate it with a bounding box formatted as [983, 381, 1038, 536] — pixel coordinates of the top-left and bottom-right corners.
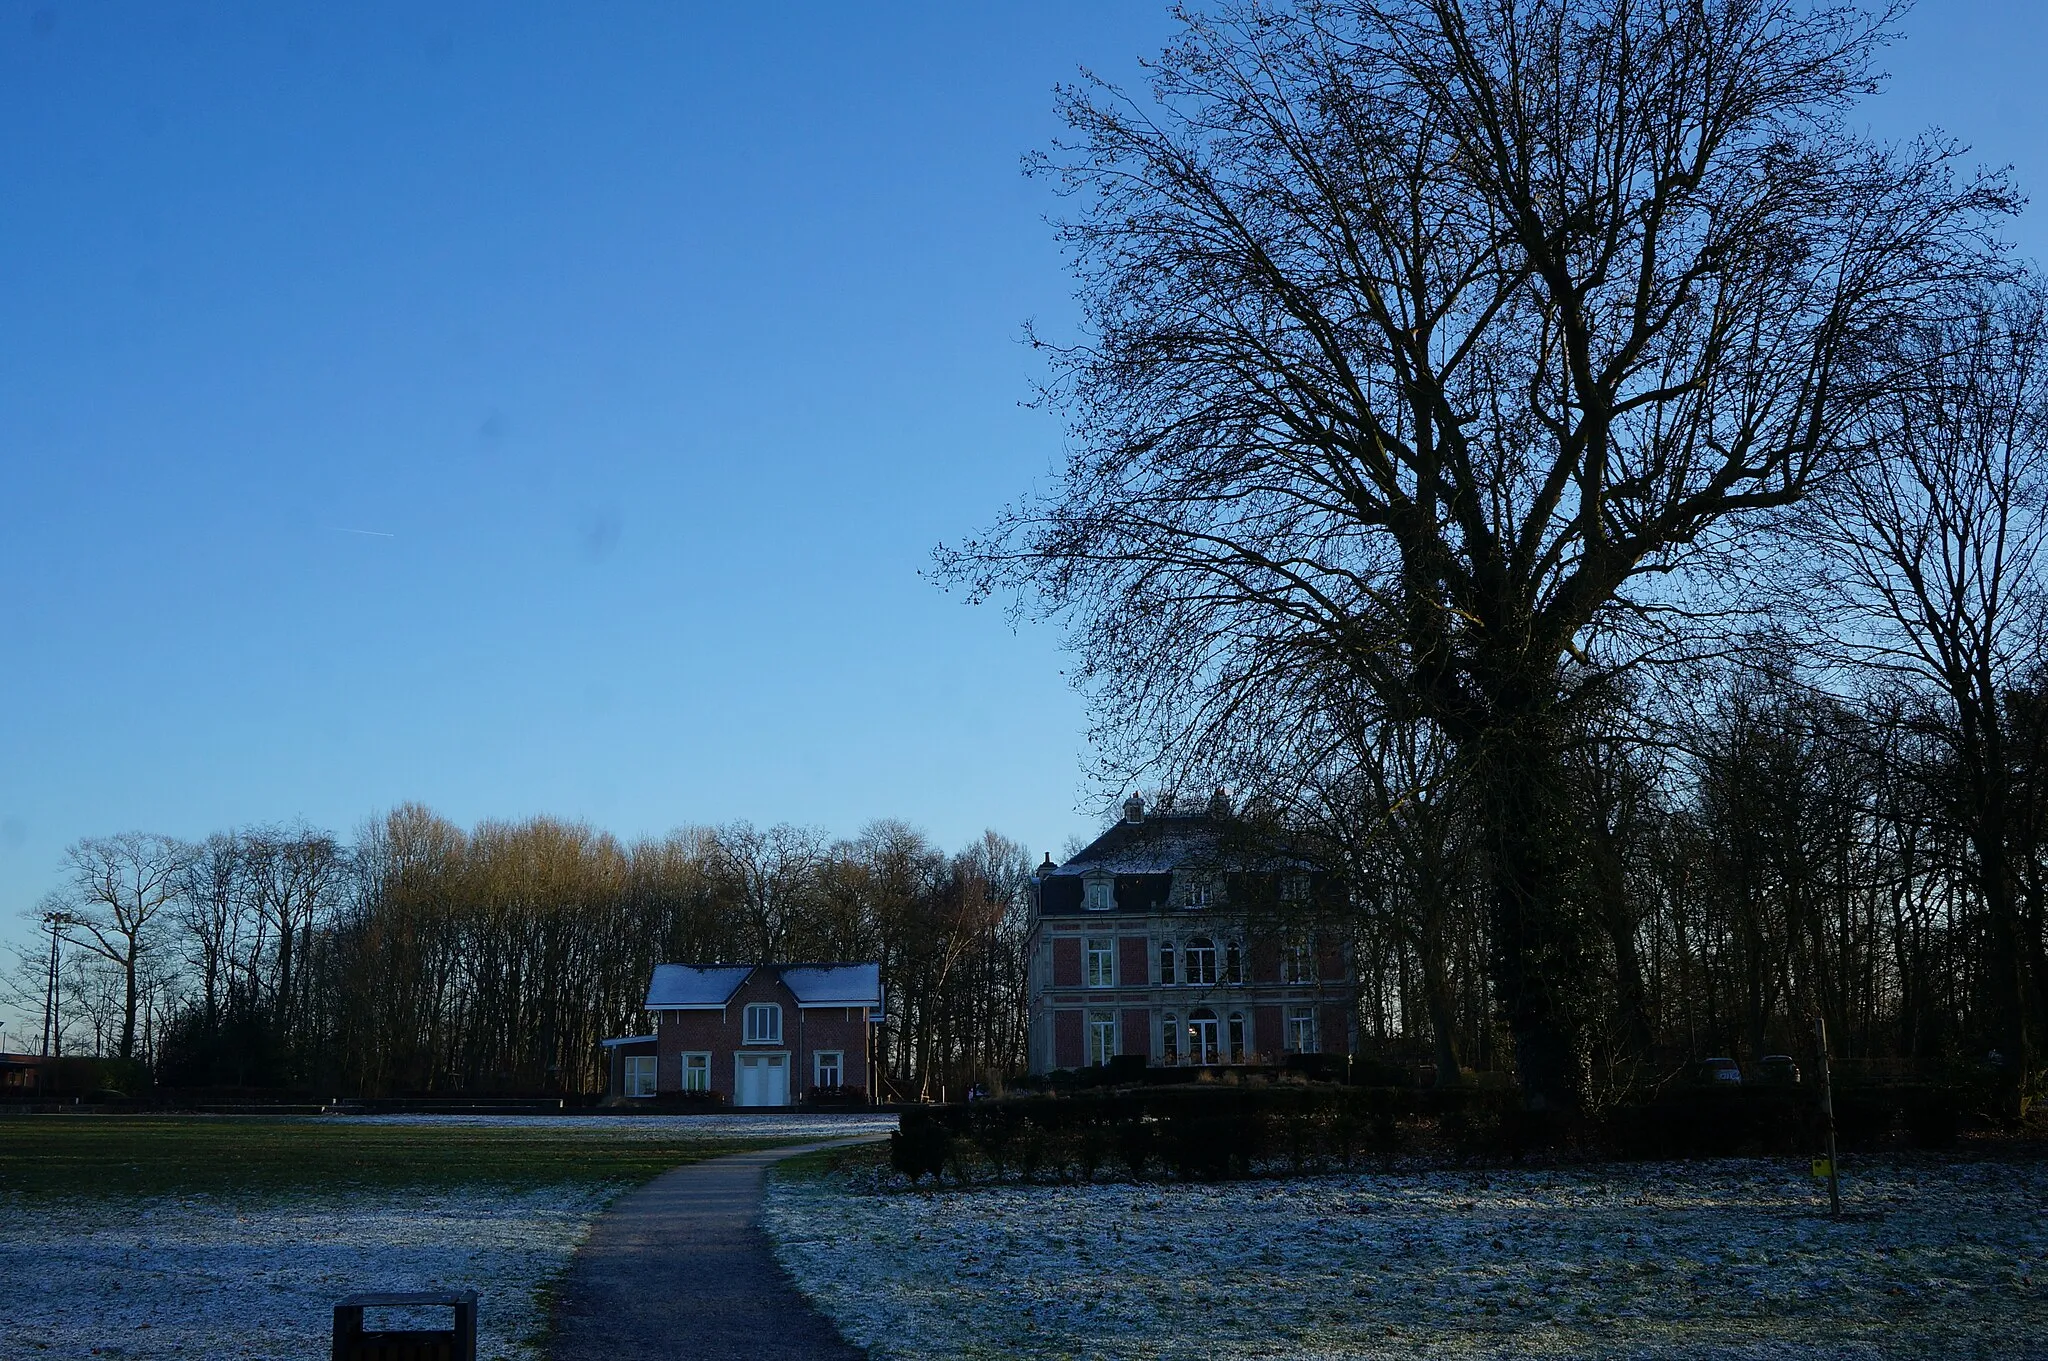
[0, 1183, 616, 1361]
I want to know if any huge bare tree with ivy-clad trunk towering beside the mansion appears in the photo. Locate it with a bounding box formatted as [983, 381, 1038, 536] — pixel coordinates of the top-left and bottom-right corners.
[940, 0, 2011, 1109]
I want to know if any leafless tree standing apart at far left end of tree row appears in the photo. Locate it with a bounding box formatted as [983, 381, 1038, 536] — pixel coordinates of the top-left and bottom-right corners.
[59, 831, 190, 1058]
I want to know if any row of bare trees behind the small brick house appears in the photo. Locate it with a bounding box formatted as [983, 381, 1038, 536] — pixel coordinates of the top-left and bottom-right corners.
[14, 804, 1030, 1095]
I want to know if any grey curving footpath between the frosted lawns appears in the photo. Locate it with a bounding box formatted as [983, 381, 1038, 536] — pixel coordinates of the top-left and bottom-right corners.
[553, 1138, 870, 1361]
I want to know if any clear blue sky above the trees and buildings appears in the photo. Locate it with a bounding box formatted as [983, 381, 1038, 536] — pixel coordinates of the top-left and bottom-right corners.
[0, 0, 2048, 1031]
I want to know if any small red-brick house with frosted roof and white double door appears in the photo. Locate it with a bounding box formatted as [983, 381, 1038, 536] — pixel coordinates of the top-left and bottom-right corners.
[604, 964, 883, 1107]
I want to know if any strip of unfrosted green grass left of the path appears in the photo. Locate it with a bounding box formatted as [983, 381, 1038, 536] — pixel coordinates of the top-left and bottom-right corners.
[0, 1115, 799, 1197]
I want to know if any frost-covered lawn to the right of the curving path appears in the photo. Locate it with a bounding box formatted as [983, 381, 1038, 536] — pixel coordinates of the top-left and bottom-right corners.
[766, 1162, 2048, 1359]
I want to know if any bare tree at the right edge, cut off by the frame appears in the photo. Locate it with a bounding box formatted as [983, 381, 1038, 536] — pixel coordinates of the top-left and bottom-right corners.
[1810, 287, 2048, 1113]
